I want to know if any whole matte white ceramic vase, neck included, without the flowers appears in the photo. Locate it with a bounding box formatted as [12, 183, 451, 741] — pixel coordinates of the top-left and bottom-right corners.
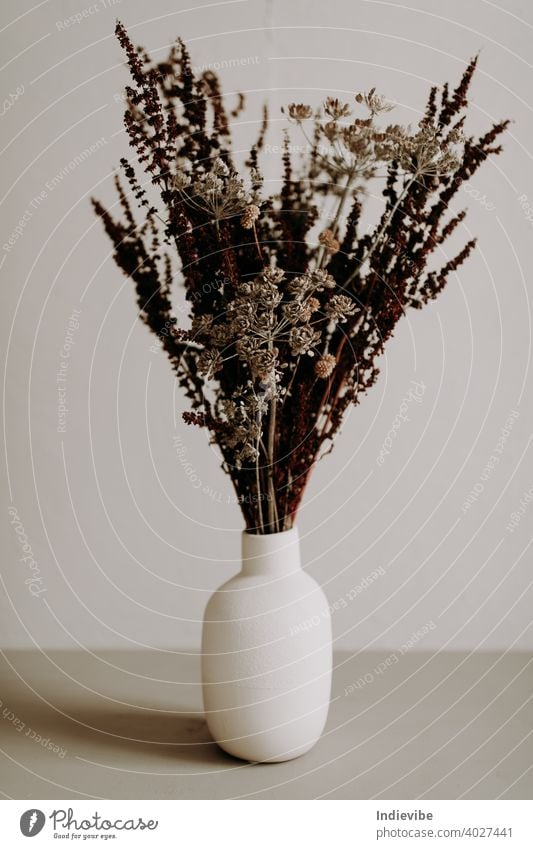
[202, 528, 332, 762]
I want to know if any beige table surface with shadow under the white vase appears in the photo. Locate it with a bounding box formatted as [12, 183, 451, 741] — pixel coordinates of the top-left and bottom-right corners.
[0, 651, 533, 799]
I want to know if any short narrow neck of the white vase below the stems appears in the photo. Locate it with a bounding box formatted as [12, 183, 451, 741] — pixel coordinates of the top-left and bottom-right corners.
[242, 528, 301, 575]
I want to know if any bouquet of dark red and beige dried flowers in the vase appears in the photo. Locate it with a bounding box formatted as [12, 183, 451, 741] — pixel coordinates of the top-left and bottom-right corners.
[94, 23, 508, 534]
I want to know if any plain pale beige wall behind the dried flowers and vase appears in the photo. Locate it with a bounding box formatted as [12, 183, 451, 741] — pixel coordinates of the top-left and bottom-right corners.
[0, 0, 533, 650]
